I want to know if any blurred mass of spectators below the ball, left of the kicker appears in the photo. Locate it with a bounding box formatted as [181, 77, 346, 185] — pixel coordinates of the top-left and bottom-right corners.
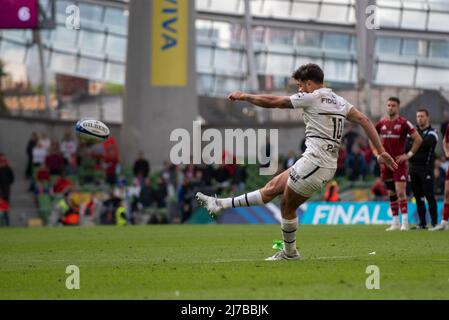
[22, 132, 247, 225]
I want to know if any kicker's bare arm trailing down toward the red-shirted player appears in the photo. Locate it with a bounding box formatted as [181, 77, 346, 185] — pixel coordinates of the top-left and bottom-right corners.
[347, 108, 398, 170]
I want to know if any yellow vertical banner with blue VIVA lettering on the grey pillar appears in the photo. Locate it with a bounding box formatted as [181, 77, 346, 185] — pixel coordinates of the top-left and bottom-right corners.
[151, 0, 189, 87]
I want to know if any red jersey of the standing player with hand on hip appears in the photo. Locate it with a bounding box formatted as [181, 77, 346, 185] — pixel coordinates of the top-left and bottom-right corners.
[376, 117, 416, 158]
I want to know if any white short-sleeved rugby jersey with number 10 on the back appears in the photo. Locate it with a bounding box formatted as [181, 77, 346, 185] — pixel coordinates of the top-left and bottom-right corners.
[290, 88, 353, 169]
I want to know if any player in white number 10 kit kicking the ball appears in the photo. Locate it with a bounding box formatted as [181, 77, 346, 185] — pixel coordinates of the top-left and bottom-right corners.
[196, 64, 397, 261]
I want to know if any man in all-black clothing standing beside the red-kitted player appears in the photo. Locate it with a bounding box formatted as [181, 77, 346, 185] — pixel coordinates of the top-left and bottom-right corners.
[408, 109, 438, 229]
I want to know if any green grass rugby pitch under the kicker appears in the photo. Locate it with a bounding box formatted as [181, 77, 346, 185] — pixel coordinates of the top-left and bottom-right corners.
[0, 225, 449, 300]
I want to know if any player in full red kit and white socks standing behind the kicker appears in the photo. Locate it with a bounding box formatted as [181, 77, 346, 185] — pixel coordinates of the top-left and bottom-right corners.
[370, 97, 422, 231]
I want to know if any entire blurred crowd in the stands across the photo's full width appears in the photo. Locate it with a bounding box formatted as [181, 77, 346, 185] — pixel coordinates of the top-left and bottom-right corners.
[0, 126, 449, 225]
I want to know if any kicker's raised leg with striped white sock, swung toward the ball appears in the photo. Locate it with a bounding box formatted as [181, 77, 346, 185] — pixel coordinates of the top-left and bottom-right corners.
[195, 169, 289, 217]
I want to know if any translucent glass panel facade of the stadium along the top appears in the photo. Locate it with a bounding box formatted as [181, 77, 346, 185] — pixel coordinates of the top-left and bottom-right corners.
[0, 0, 449, 120]
